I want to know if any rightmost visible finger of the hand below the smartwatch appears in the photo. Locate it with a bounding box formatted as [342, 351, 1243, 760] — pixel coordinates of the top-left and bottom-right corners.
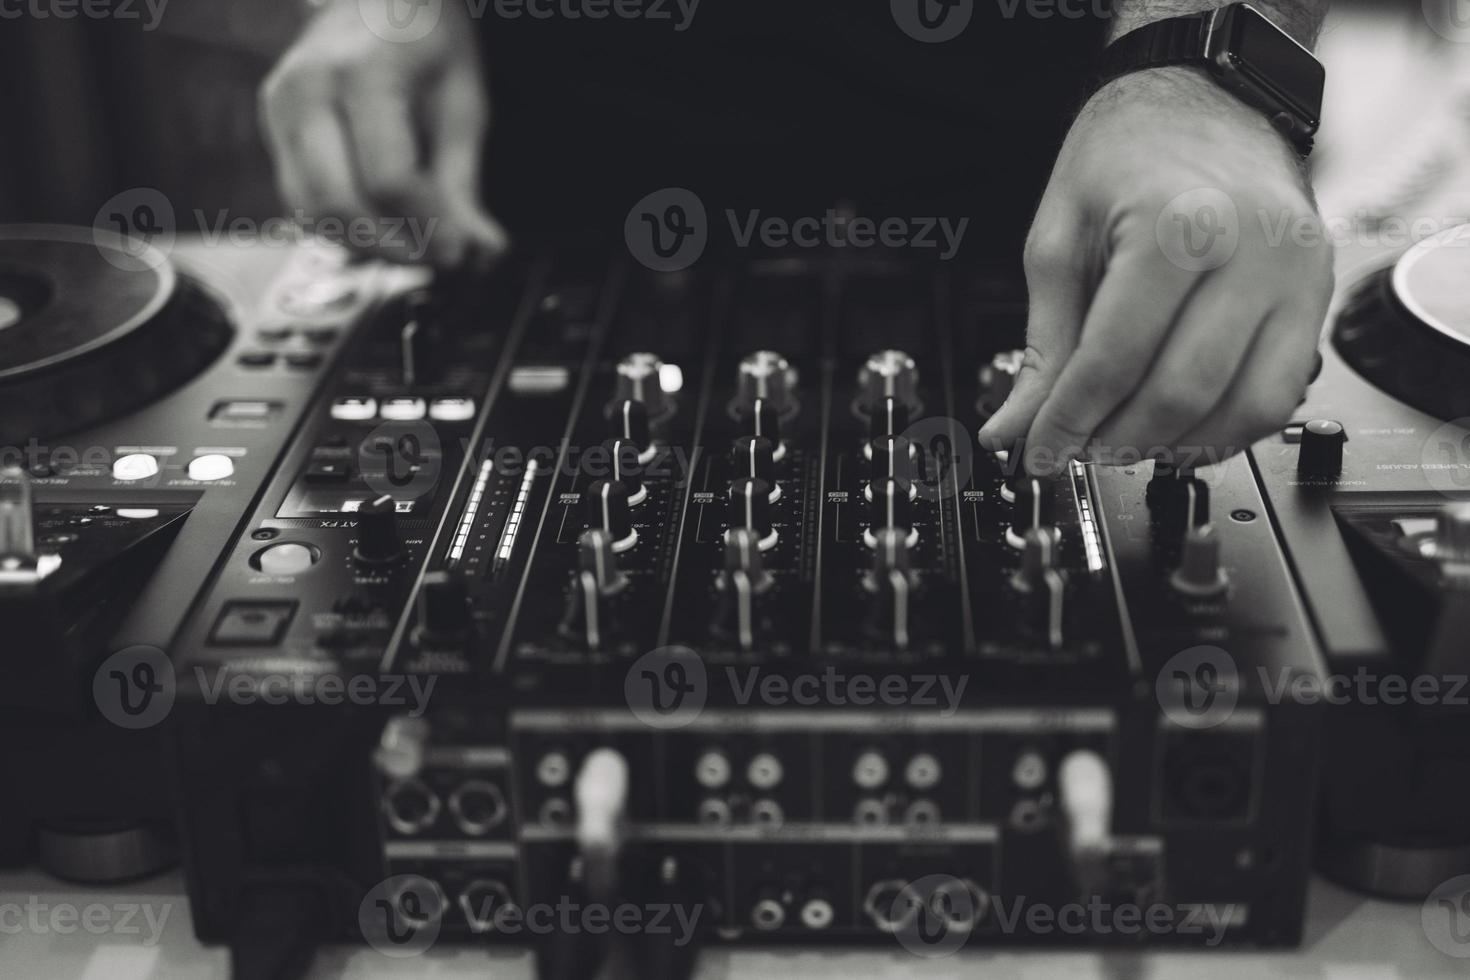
[1179, 303, 1324, 461]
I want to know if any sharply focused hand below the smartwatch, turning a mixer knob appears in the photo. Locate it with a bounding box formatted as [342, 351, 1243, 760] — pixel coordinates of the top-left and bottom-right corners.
[980, 68, 1332, 475]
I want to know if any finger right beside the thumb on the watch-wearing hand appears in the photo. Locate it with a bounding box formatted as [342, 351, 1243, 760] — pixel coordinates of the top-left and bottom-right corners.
[1026, 239, 1201, 475]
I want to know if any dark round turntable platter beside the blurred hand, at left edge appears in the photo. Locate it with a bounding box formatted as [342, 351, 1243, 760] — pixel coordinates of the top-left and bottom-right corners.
[0, 226, 232, 445]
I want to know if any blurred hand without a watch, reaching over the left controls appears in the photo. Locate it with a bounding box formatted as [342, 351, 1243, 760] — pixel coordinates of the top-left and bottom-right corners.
[260, 0, 506, 266]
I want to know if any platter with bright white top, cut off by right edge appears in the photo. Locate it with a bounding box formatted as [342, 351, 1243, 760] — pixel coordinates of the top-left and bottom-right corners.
[1332, 225, 1470, 420]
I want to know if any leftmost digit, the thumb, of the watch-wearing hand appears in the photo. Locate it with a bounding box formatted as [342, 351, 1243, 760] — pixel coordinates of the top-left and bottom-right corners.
[979, 231, 1086, 451]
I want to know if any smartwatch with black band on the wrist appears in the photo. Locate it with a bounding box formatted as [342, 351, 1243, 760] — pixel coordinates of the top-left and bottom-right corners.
[1097, 3, 1327, 157]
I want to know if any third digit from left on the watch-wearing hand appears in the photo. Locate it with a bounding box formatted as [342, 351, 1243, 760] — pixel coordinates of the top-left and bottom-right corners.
[1089, 276, 1269, 463]
